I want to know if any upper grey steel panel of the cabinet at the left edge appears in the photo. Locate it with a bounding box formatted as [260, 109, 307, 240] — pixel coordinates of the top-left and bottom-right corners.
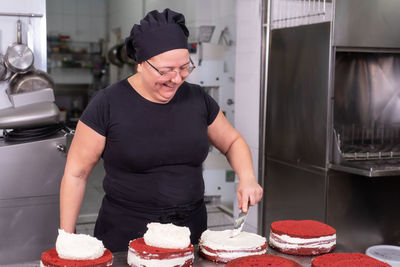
[0, 135, 66, 199]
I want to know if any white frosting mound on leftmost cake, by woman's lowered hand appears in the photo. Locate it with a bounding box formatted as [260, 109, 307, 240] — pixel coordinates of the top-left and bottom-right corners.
[56, 229, 106, 260]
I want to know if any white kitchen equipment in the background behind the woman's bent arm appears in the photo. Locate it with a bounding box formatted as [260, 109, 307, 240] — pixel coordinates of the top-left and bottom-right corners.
[186, 39, 235, 213]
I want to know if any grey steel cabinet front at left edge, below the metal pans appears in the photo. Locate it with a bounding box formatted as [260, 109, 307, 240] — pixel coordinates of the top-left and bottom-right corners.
[0, 132, 66, 264]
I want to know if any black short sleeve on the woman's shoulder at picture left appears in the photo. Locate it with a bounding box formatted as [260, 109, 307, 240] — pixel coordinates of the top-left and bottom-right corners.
[80, 90, 110, 136]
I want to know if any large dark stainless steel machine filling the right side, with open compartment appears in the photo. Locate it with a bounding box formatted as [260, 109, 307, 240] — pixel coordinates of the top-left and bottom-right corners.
[261, 0, 400, 252]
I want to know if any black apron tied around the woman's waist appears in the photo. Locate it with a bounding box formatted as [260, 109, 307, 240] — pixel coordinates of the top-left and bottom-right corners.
[94, 195, 207, 252]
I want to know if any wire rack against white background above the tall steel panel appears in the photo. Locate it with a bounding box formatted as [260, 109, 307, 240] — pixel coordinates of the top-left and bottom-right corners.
[271, 0, 333, 29]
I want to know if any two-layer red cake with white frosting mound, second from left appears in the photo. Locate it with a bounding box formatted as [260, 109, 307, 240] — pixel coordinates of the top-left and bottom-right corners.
[127, 223, 194, 267]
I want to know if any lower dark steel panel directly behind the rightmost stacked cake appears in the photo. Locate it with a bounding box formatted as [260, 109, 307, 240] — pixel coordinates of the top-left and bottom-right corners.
[261, 159, 326, 236]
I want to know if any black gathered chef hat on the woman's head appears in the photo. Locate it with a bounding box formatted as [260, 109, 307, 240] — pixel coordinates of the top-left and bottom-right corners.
[125, 8, 189, 63]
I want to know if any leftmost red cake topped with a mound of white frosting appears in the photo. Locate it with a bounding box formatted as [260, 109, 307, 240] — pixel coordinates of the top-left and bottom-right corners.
[40, 229, 113, 267]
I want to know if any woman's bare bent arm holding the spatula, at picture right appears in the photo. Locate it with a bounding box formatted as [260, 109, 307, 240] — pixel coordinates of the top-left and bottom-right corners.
[207, 110, 263, 213]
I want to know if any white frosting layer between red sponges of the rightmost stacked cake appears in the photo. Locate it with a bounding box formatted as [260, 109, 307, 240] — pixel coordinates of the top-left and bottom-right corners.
[269, 232, 336, 249]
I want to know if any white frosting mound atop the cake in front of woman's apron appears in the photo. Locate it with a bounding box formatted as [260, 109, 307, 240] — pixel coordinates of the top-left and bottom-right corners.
[143, 223, 190, 249]
